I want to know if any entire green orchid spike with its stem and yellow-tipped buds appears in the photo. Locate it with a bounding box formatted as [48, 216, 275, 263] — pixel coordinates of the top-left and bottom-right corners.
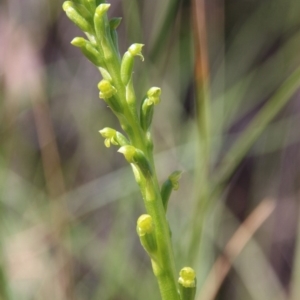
[63, 0, 196, 300]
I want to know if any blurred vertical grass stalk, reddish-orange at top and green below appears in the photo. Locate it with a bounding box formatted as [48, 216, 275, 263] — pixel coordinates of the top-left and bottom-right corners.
[188, 0, 211, 263]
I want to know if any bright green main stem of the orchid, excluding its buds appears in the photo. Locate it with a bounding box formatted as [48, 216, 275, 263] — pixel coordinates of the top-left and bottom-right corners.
[106, 40, 180, 300]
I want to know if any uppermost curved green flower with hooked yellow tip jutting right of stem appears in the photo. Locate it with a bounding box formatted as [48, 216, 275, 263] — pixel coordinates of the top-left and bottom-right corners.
[121, 44, 144, 85]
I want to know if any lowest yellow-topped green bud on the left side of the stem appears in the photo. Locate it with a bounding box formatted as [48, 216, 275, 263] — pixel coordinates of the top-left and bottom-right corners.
[136, 214, 157, 260]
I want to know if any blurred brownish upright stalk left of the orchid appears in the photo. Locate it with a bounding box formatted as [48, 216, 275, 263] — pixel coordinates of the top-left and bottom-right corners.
[32, 90, 74, 300]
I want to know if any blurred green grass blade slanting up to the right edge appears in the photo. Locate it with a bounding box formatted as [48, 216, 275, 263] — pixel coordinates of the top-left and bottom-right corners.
[190, 68, 300, 272]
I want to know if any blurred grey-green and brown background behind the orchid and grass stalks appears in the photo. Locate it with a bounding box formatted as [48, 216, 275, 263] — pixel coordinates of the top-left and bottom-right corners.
[0, 0, 300, 300]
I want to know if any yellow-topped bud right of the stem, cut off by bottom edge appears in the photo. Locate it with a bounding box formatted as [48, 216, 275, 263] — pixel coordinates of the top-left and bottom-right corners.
[178, 267, 196, 300]
